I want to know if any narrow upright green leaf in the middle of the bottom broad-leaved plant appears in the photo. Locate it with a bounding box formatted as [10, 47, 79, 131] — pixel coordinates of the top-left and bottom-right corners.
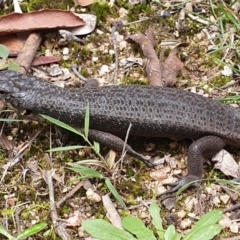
[149, 203, 164, 239]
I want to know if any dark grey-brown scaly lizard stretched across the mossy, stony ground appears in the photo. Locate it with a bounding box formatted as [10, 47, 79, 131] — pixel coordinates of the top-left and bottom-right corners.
[0, 71, 240, 192]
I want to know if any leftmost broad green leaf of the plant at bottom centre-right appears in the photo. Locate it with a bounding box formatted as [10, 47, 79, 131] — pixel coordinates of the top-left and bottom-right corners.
[82, 219, 137, 240]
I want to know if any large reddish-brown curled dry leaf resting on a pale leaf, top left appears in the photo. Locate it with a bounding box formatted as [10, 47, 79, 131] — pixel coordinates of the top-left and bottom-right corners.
[0, 10, 85, 35]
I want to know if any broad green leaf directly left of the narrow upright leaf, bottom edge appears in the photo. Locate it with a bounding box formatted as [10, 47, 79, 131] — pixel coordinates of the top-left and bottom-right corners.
[122, 217, 156, 240]
